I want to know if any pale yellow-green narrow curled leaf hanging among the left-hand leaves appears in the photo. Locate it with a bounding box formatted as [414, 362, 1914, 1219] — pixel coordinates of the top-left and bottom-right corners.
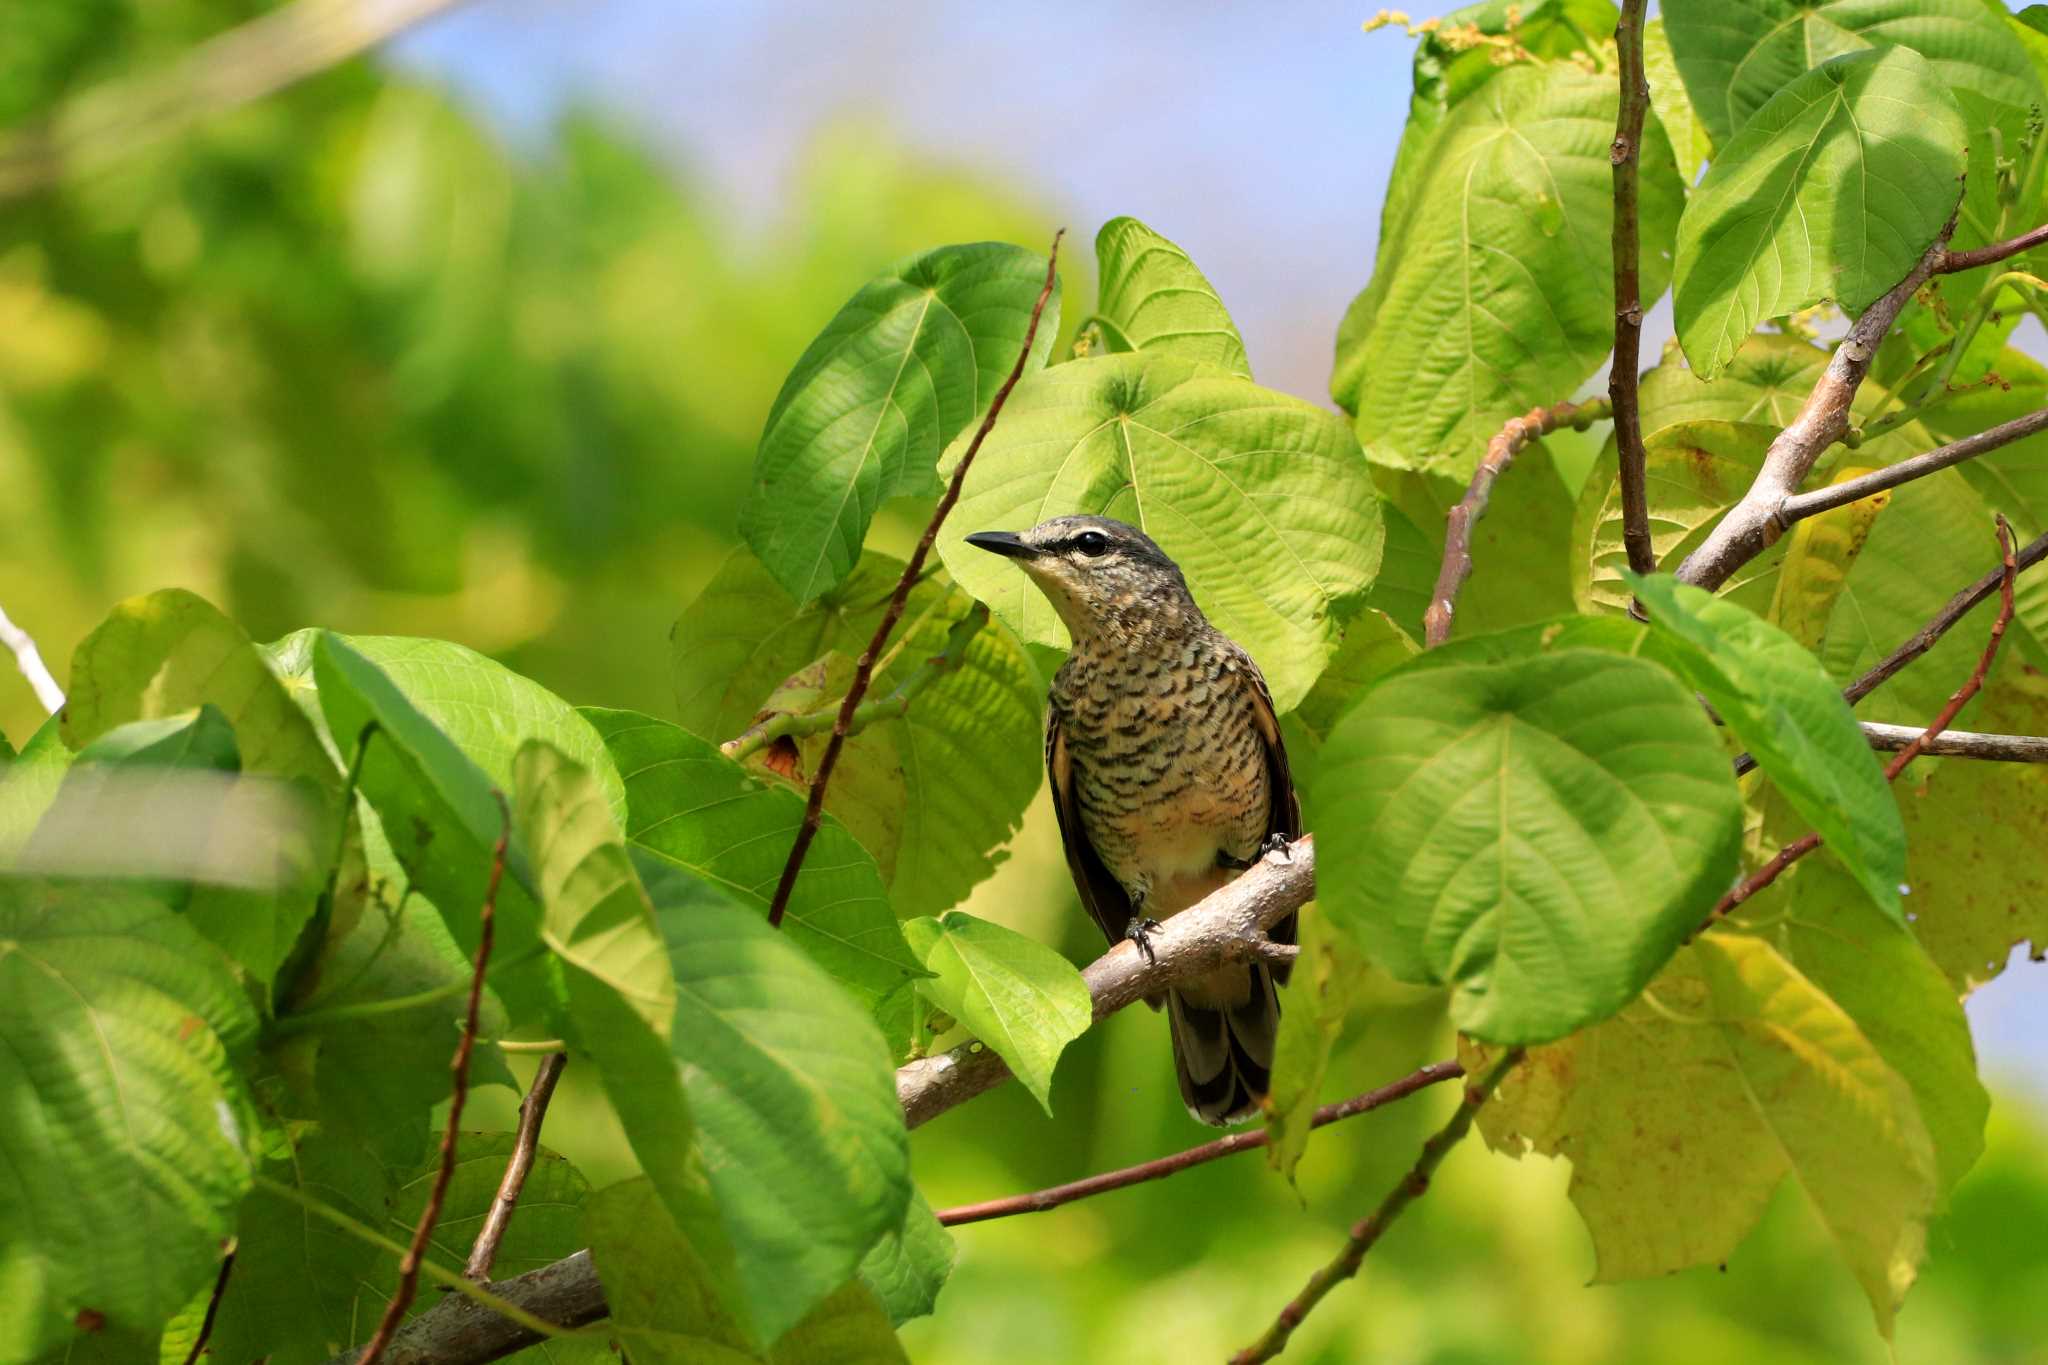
[512, 739, 676, 1038]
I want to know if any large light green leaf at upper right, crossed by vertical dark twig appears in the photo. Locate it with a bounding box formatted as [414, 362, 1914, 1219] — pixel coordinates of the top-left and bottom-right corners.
[1331, 61, 1681, 479]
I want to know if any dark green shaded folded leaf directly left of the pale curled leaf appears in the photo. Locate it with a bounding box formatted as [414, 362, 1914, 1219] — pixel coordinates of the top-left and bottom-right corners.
[313, 632, 553, 1019]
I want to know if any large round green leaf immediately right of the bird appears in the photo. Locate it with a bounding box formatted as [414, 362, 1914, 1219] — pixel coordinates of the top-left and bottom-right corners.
[1317, 636, 1741, 1044]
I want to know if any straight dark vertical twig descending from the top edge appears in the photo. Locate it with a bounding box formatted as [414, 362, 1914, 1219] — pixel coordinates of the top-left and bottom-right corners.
[1608, 0, 1657, 573]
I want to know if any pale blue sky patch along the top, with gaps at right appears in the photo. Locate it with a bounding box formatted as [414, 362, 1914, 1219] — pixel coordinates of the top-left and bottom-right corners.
[393, 0, 2048, 1105]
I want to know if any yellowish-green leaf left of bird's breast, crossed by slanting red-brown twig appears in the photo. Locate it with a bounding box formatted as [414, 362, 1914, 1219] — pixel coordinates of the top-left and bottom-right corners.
[670, 551, 1044, 915]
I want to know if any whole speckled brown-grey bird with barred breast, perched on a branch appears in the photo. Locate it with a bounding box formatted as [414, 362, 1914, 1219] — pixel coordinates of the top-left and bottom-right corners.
[967, 516, 1300, 1126]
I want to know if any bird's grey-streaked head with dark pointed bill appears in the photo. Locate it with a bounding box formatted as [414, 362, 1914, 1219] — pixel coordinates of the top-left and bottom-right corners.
[967, 516, 1194, 641]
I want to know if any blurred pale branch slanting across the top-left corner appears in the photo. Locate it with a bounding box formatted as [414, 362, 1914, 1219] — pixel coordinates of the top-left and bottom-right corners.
[0, 0, 459, 199]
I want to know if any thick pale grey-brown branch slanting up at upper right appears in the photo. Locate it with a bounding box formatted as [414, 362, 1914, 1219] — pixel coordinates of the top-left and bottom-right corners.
[1677, 217, 1956, 591]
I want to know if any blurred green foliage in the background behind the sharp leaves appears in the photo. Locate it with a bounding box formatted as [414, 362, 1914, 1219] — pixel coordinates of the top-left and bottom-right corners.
[0, 0, 2048, 1365]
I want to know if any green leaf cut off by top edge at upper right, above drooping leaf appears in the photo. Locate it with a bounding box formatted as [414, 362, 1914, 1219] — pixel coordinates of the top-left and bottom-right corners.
[1665, 0, 2040, 147]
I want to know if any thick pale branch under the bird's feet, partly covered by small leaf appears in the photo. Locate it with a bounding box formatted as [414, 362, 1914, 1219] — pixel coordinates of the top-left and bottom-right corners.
[897, 835, 1315, 1128]
